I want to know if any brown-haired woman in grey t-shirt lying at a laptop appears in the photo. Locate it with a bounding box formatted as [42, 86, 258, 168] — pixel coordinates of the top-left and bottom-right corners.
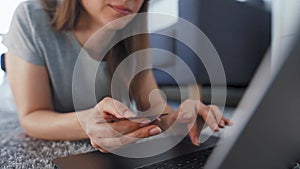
[3, 0, 231, 152]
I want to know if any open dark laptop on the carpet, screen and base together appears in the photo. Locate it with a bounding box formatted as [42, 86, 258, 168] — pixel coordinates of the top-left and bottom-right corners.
[54, 31, 300, 169]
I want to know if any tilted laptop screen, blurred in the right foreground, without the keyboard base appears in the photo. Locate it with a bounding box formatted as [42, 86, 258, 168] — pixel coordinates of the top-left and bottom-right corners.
[207, 1, 300, 169]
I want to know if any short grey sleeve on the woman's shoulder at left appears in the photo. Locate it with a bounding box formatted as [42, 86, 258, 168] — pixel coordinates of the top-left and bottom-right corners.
[2, 2, 45, 65]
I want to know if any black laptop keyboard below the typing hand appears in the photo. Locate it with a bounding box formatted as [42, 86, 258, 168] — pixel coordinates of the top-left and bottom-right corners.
[138, 148, 213, 169]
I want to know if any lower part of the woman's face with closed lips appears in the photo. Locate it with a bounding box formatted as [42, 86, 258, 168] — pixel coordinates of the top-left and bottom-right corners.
[81, 0, 144, 29]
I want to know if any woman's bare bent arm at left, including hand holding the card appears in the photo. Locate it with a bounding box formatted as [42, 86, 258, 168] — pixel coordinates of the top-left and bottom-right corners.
[6, 53, 161, 148]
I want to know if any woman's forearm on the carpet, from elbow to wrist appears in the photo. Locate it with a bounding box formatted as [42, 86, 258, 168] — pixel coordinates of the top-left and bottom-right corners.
[20, 110, 89, 140]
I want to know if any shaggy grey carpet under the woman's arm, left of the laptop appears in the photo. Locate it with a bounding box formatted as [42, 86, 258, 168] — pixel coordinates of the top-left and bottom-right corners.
[0, 112, 94, 169]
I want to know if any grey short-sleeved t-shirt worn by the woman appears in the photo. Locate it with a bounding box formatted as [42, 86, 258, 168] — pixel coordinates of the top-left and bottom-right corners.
[3, 0, 110, 112]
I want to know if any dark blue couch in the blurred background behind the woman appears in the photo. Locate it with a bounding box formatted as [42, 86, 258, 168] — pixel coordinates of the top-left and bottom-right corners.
[150, 0, 271, 104]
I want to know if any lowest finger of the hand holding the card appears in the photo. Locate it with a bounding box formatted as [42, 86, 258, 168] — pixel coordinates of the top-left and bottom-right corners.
[97, 125, 161, 151]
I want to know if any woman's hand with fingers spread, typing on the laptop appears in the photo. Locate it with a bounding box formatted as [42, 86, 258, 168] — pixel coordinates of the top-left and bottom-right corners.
[162, 99, 233, 145]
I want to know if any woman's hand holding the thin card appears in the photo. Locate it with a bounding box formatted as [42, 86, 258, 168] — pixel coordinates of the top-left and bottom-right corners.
[77, 97, 161, 152]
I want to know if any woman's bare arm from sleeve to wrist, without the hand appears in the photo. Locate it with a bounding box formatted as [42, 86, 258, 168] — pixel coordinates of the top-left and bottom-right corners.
[6, 53, 88, 140]
